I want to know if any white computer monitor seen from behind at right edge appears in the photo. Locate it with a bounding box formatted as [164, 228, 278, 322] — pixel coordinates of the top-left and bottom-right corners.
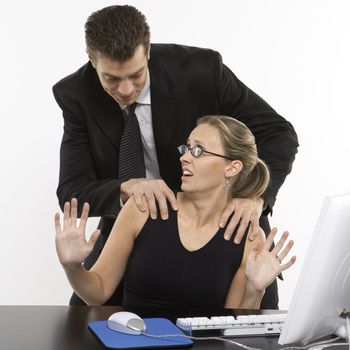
[278, 193, 350, 345]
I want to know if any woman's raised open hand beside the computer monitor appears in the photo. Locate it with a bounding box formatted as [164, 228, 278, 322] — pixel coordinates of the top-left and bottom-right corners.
[246, 228, 296, 291]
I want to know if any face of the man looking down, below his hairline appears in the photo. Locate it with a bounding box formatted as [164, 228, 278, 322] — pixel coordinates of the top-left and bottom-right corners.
[91, 45, 148, 106]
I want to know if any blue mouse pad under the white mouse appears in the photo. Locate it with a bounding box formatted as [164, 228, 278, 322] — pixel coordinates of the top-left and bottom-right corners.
[89, 318, 193, 349]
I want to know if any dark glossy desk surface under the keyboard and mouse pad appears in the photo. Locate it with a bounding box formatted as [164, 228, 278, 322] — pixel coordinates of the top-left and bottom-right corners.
[0, 306, 345, 350]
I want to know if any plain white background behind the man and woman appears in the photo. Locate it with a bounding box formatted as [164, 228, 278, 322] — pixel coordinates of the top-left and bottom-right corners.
[0, 0, 350, 309]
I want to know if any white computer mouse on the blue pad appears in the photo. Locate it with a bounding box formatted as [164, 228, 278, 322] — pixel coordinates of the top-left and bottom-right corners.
[107, 311, 146, 335]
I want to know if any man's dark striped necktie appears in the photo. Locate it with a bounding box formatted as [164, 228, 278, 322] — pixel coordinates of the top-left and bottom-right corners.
[119, 102, 146, 180]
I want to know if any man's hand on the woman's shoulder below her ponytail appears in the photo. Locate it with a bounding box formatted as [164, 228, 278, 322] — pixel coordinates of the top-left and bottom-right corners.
[219, 198, 264, 244]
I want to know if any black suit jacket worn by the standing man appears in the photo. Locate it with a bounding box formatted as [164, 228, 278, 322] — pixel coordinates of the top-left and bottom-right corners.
[53, 44, 298, 308]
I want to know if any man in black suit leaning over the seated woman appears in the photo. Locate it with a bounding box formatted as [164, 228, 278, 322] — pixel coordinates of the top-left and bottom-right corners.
[53, 6, 298, 308]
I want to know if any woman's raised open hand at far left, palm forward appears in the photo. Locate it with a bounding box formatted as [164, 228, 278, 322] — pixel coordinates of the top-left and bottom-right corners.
[55, 198, 100, 267]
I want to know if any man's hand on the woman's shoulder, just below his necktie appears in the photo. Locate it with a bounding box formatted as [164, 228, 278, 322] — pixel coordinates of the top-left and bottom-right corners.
[120, 179, 178, 220]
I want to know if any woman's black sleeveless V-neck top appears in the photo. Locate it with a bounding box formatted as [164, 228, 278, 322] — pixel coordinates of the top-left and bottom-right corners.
[123, 209, 246, 308]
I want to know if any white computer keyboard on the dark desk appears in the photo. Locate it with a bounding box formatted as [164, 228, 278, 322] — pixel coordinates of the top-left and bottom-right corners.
[176, 313, 287, 337]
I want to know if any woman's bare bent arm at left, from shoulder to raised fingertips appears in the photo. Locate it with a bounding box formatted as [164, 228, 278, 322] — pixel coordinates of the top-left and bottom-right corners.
[55, 197, 148, 305]
